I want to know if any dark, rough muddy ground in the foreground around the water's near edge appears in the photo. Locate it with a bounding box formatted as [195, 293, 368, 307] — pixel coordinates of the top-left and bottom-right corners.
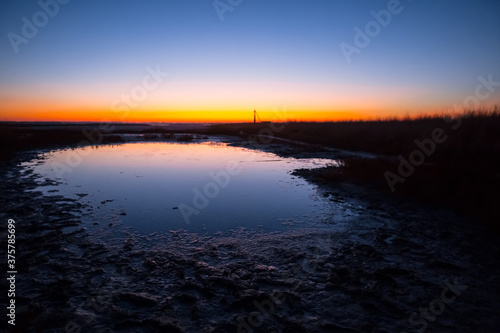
[0, 141, 500, 333]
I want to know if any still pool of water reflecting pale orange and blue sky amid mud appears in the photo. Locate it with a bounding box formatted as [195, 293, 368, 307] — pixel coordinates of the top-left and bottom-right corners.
[23, 141, 345, 234]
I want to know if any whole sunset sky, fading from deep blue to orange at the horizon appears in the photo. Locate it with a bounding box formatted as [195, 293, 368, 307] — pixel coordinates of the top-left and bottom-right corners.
[0, 0, 500, 122]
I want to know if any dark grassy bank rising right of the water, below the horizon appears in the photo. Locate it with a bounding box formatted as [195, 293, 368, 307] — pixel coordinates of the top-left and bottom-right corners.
[211, 111, 500, 227]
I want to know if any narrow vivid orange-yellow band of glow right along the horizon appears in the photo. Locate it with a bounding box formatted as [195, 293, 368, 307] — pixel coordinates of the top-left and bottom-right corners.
[0, 96, 472, 123]
